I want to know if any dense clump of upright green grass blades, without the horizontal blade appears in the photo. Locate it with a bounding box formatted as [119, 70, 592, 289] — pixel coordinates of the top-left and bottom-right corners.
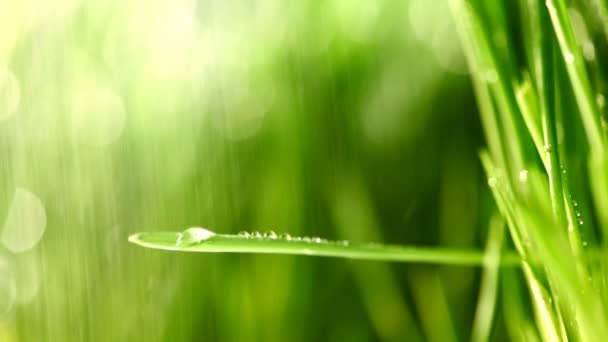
[451, 0, 608, 341]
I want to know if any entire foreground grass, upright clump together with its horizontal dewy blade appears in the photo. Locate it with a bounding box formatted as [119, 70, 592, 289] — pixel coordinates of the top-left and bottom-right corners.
[129, 0, 608, 341]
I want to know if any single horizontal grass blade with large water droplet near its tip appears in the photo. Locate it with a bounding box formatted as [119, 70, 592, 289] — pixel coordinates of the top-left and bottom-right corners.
[129, 228, 521, 266]
